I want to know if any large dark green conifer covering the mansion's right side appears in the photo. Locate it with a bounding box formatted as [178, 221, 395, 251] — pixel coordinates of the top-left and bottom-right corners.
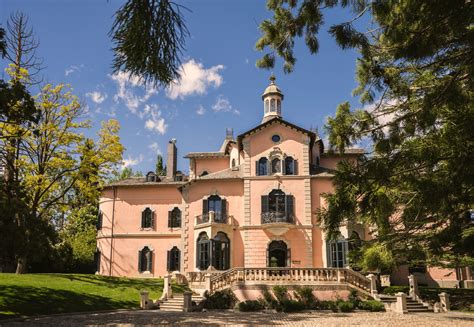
[257, 0, 474, 267]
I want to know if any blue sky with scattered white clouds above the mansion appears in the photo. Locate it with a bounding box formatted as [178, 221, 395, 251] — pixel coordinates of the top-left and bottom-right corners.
[0, 0, 366, 172]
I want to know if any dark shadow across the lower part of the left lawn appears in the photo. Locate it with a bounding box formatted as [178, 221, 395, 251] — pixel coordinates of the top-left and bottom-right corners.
[0, 285, 139, 319]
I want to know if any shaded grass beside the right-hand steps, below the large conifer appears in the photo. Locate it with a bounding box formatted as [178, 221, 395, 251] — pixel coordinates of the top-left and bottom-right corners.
[382, 286, 474, 312]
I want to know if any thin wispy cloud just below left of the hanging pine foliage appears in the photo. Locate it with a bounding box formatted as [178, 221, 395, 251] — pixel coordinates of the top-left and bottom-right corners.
[109, 71, 158, 114]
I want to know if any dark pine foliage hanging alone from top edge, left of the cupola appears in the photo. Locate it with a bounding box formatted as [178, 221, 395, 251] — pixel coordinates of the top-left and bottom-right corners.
[110, 0, 189, 87]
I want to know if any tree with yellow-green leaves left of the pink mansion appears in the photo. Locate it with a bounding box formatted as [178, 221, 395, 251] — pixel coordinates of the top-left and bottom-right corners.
[16, 84, 123, 273]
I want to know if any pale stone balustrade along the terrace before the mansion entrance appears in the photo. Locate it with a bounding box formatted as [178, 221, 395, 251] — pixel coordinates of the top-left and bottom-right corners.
[209, 267, 371, 292]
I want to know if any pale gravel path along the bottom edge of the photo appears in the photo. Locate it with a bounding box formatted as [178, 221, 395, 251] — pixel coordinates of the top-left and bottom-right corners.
[0, 311, 474, 327]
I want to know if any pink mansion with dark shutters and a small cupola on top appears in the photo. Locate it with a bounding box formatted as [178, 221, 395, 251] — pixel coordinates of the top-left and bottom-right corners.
[96, 78, 466, 286]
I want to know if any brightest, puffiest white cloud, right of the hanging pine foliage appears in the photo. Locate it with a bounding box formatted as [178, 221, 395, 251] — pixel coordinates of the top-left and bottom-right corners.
[166, 59, 224, 100]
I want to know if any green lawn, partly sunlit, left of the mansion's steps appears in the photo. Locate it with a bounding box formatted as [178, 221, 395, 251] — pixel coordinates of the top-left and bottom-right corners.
[0, 274, 186, 319]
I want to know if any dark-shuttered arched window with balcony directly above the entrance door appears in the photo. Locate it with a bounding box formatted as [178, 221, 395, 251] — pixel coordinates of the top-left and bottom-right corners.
[261, 190, 294, 224]
